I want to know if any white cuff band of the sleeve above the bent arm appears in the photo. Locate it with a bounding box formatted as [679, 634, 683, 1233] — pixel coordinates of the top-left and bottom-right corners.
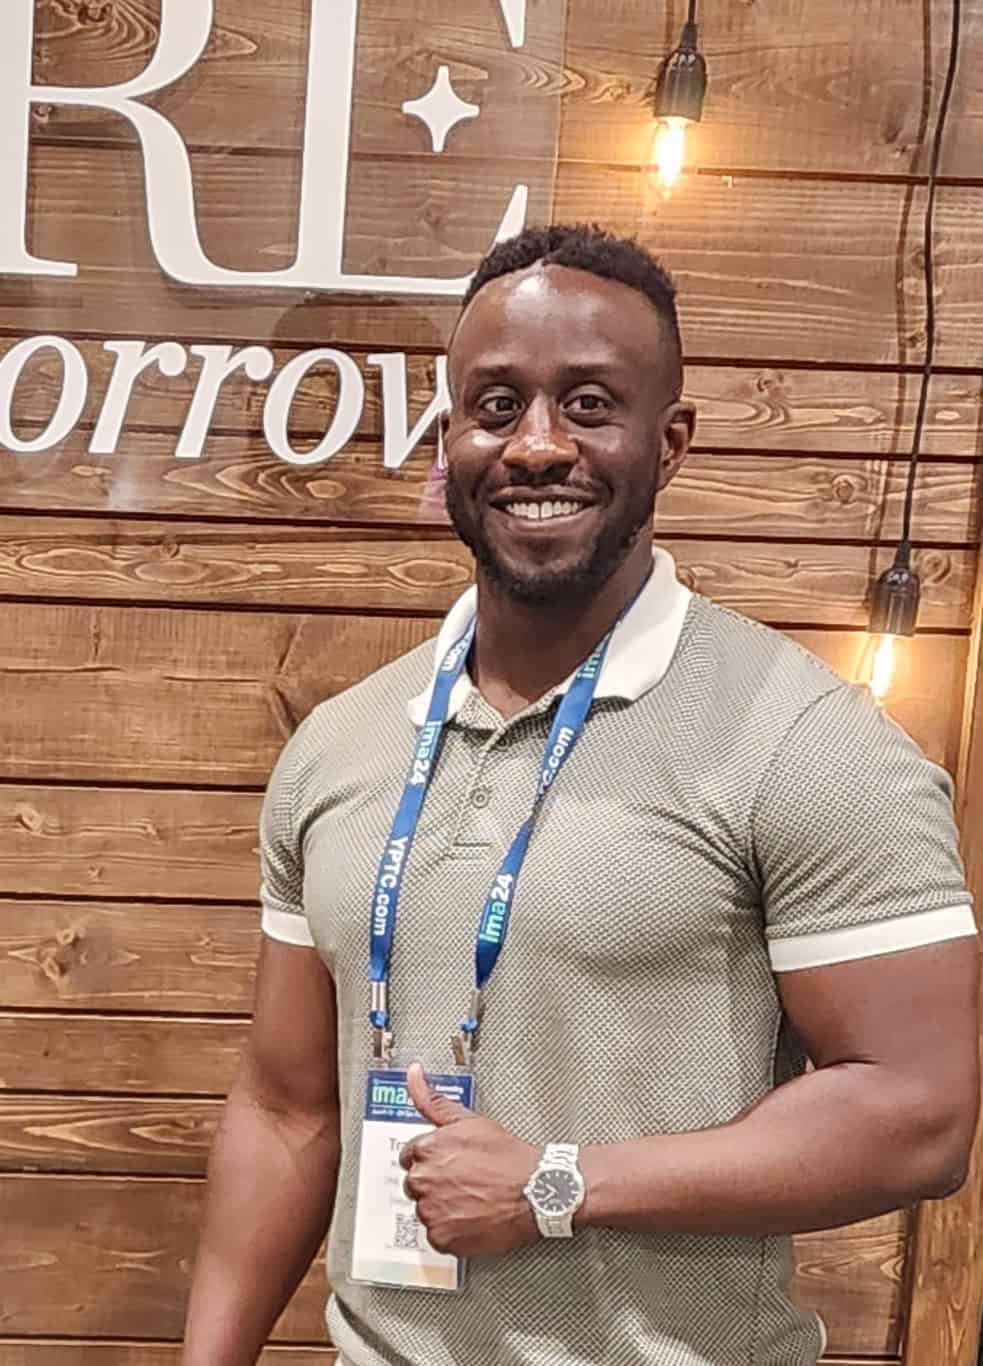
[769, 906, 976, 973]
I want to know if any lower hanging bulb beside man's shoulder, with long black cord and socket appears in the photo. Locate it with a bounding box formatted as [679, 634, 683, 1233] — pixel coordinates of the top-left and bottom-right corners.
[870, 0, 963, 702]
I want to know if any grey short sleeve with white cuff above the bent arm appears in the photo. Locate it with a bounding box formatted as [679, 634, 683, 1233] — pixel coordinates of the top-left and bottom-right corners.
[751, 686, 976, 973]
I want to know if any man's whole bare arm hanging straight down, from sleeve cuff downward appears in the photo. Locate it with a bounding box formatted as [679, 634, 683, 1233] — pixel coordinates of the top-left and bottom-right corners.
[183, 936, 340, 1366]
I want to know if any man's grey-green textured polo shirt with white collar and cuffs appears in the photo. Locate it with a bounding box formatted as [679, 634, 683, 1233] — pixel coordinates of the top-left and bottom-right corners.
[262, 550, 975, 1366]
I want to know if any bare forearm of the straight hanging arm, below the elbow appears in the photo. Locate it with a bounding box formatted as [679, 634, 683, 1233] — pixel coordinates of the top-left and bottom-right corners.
[183, 1082, 340, 1366]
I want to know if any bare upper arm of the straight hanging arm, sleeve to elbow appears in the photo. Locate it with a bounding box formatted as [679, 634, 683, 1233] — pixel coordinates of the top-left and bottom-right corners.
[243, 934, 337, 1113]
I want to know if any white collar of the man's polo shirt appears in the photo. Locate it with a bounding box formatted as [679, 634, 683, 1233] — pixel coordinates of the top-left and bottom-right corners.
[407, 548, 692, 725]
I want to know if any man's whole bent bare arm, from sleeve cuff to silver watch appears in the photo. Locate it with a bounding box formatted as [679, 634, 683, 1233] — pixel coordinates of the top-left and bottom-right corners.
[576, 938, 979, 1235]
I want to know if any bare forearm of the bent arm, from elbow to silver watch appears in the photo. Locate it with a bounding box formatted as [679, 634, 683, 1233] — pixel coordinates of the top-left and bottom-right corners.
[578, 1063, 971, 1235]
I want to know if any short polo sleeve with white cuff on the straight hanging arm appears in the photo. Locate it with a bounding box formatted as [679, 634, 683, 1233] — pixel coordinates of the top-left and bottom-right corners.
[259, 732, 314, 947]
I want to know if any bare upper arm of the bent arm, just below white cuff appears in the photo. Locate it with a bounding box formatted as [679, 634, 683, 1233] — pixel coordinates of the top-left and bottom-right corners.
[777, 936, 979, 1092]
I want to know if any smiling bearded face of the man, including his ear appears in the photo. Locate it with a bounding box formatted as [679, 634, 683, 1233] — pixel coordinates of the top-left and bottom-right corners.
[445, 265, 692, 604]
